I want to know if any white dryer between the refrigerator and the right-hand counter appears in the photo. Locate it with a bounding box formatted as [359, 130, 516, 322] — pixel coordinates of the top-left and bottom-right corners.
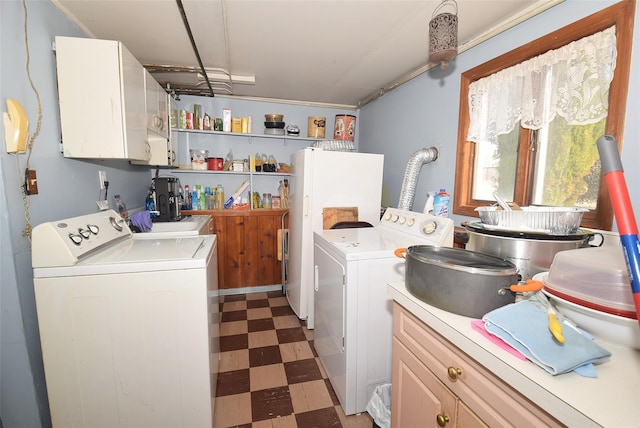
[314, 208, 453, 415]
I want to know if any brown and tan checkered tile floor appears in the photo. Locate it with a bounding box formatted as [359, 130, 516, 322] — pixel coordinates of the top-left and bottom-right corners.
[214, 291, 373, 428]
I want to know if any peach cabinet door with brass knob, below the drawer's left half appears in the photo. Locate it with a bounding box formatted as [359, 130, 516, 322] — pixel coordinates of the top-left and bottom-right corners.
[391, 337, 457, 427]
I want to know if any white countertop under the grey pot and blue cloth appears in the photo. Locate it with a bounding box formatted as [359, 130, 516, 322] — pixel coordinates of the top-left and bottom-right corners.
[388, 282, 640, 428]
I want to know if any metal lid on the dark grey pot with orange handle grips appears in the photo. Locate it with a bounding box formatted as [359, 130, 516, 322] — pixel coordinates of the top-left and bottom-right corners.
[407, 245, 517, 275]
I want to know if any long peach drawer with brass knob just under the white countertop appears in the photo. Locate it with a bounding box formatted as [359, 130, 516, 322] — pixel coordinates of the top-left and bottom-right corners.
[393, 303, 562, 428]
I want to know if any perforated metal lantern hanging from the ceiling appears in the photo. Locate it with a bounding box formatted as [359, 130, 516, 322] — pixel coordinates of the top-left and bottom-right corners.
[429, 0, 458, 70]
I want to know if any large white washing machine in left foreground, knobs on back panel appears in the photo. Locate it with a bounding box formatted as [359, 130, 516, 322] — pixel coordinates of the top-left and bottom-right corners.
[32, 210, 219, 428]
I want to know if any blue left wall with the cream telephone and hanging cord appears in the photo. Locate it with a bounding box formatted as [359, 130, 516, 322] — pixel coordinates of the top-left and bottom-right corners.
[0, 0, 150, 427]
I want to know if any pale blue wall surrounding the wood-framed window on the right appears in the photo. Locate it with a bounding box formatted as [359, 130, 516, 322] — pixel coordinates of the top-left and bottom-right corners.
[359, 0, 640, 228]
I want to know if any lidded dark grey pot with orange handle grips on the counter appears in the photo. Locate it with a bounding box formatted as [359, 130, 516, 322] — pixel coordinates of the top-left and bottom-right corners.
[398, 245, 518, 318]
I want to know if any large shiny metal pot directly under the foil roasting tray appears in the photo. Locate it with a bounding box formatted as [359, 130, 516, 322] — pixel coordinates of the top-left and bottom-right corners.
[465, 223, 594, 281]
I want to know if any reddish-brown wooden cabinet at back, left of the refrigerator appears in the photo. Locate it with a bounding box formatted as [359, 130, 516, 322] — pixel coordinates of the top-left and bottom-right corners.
[190, 210, 287, 289]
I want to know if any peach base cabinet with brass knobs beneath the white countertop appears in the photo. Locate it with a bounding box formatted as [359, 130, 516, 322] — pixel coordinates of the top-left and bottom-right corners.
[391, 302, 562, 428]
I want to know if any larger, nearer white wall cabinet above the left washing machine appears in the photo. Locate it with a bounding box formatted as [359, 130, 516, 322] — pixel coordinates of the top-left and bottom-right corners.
[55, 37, 151, 161]
